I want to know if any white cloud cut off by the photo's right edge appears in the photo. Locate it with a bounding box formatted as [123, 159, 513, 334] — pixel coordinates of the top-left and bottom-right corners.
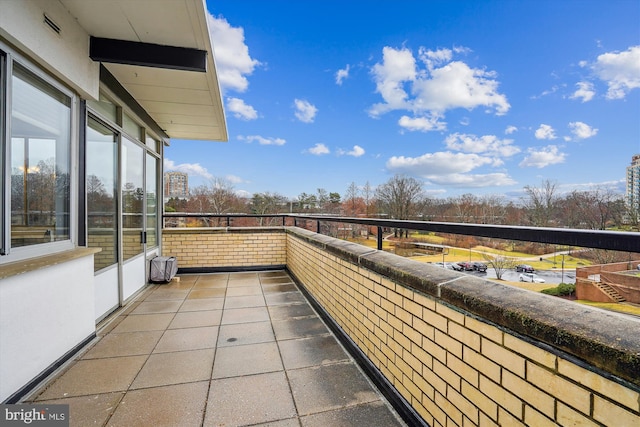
[593, 46, 640, 99]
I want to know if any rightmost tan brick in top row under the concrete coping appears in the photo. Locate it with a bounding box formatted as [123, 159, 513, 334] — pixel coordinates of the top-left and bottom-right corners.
[558, 359, 640, 412]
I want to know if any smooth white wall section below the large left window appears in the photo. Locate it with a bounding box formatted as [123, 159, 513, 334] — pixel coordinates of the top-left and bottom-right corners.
[0, 254, 96, 402]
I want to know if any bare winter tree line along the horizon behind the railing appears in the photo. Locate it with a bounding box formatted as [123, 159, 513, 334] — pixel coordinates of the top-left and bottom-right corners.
[165, 175, 639, 230]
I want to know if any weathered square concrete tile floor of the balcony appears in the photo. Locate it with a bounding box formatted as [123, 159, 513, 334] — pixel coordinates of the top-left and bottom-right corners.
[29, 271, 404, 427]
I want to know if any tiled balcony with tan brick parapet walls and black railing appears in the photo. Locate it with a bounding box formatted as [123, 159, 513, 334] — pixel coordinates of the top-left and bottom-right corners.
[20, 219, 640, 426]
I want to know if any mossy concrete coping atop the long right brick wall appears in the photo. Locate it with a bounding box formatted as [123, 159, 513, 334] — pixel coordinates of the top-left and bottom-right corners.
[286, 227, 640, 390]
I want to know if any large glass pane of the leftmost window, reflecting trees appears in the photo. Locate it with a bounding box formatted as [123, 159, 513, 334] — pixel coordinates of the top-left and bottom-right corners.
[11, 64, 71, 247]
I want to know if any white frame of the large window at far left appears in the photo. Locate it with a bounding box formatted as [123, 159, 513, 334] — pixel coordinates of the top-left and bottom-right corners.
[0, 41, 80, 264]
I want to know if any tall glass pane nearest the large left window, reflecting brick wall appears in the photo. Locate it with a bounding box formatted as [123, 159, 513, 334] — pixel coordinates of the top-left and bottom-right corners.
[87, 118, 118, 271]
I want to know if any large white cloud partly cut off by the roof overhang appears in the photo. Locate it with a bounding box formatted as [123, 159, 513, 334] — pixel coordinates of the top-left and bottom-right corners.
[207, 14, 261, 93]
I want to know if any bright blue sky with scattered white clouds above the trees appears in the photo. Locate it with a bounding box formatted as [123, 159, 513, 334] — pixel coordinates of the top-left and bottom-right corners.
[165, 0, 640, 199]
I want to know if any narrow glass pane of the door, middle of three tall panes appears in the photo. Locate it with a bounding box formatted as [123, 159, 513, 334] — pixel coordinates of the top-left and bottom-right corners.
[121, 139, 144, 260]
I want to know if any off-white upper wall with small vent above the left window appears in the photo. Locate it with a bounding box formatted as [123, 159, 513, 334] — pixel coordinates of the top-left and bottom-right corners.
[0, 0, 100, 99]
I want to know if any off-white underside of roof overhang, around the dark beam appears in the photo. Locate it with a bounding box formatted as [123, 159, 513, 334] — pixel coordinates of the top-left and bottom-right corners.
[60, 0, 228, 141]
